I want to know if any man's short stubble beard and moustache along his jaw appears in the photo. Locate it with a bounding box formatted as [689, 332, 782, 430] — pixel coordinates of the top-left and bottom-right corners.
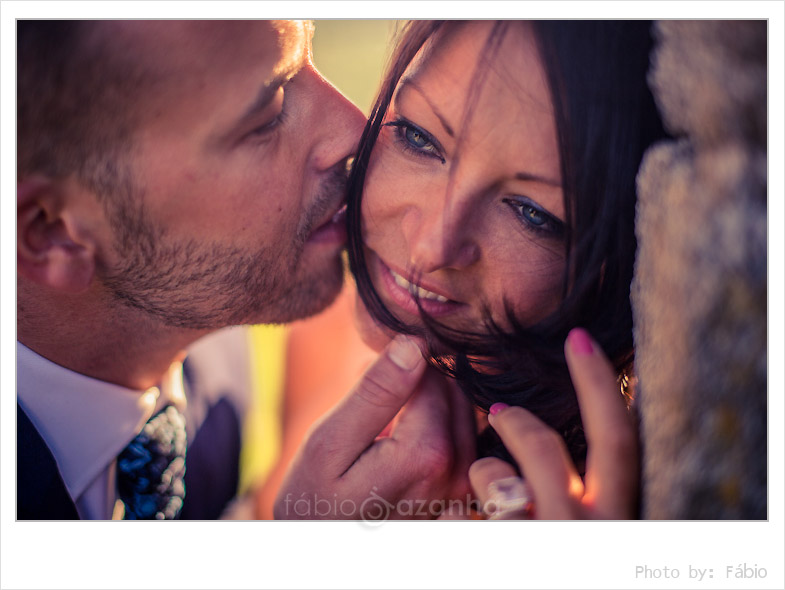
[101, 172, 345, 330]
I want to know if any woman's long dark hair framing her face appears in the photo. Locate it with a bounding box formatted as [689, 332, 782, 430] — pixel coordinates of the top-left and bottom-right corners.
[348, 21, 663, 470]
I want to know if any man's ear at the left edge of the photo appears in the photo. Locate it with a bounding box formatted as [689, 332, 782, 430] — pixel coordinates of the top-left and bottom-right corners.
[16, 177, 96, 293]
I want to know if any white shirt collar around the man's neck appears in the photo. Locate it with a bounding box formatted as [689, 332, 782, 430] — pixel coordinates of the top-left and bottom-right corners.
[16, 342, 185, 499]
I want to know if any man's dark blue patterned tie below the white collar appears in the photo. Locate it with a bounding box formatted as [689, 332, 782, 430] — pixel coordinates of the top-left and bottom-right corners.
[117, 406, 186, 520]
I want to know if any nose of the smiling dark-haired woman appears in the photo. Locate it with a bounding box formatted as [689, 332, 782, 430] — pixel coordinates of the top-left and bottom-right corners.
[402, 202, 480, 273]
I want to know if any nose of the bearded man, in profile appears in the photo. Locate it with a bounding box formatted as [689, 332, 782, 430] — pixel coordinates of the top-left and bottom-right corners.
[309, 69, 366, 170]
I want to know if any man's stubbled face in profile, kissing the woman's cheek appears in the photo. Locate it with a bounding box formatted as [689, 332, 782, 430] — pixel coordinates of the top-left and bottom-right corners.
[99, 21, 364, 329]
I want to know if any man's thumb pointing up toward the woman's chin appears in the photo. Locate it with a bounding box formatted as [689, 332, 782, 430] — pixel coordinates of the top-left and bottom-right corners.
[304, 335, 426, 477]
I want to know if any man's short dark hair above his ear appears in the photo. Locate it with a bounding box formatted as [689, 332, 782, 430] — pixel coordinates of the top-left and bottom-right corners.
[17, 20, 145, 198]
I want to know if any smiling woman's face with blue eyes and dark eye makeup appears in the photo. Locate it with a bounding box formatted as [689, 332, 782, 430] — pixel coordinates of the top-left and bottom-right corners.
[358, 22, 565, 347]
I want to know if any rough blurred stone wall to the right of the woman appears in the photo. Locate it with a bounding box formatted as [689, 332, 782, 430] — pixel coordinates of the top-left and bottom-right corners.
[632, 21, 767, 519]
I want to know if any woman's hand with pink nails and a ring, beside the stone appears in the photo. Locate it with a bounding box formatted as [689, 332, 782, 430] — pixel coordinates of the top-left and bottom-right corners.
[469, 328, 639, 520]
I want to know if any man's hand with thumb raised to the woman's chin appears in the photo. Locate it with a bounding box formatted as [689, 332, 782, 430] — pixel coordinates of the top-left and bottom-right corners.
[274, 336, 476, 520]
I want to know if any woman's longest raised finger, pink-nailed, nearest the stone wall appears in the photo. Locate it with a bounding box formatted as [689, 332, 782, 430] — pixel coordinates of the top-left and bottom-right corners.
[564, 328, 638, 518]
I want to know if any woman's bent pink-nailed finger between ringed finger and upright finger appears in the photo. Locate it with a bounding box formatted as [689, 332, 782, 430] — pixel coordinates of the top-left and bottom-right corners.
[488, 404, 583, 520]
